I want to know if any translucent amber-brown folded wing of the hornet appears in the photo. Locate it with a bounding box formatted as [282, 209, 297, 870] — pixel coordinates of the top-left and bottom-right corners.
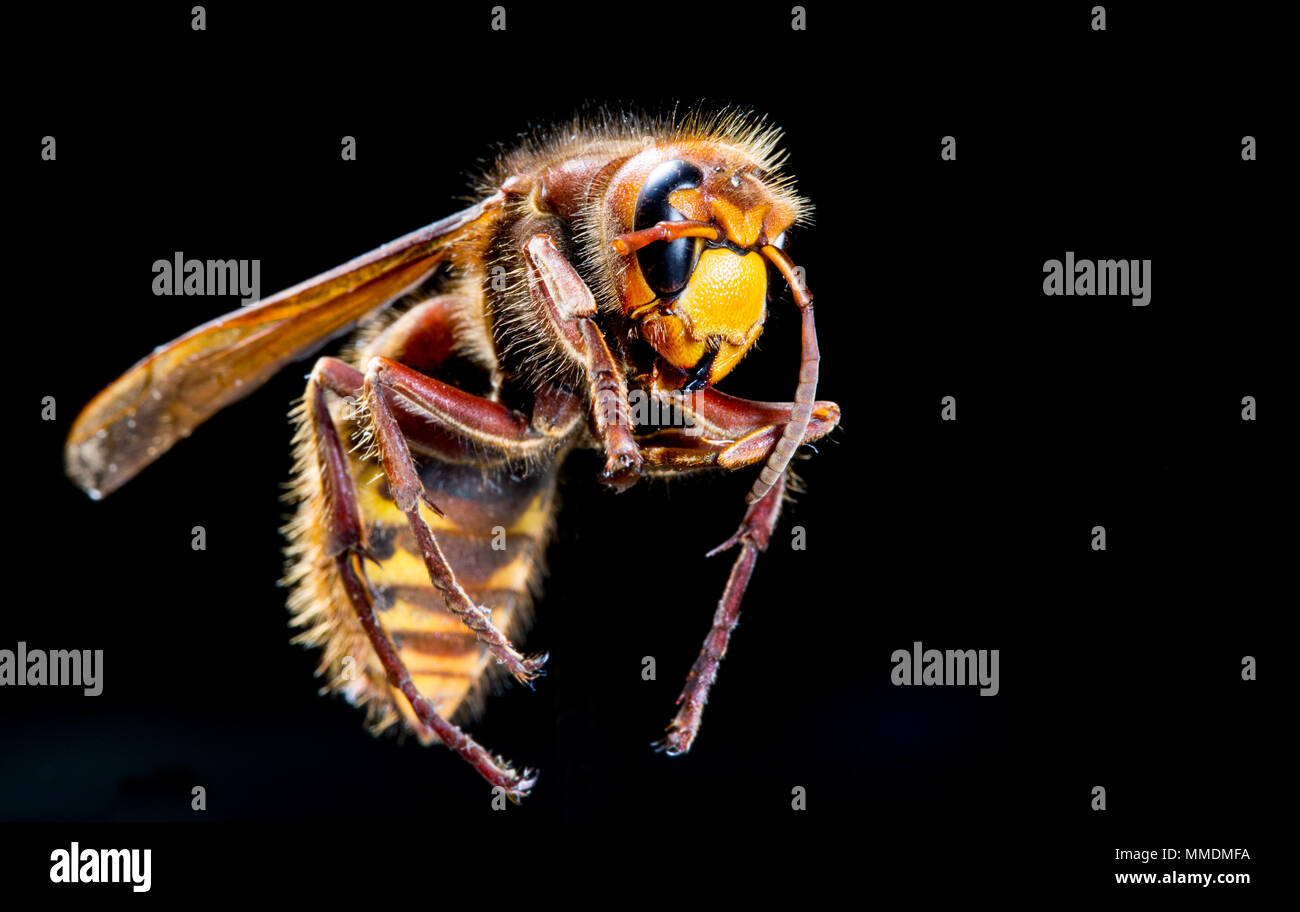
[64, 192, 504, 500]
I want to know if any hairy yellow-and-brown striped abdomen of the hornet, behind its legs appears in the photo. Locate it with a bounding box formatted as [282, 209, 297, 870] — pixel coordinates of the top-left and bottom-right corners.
[286, 407, 556, 741]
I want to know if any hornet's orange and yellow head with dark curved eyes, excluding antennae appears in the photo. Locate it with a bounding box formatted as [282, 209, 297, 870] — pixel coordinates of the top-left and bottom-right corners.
[611, 144, 796, 386]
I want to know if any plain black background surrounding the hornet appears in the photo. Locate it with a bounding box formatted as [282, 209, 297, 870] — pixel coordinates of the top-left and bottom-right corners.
[0, 4, 1294, 893]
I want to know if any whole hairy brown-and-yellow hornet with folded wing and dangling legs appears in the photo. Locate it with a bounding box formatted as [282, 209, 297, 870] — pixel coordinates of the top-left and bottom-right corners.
[65, 113, 840, 799]
